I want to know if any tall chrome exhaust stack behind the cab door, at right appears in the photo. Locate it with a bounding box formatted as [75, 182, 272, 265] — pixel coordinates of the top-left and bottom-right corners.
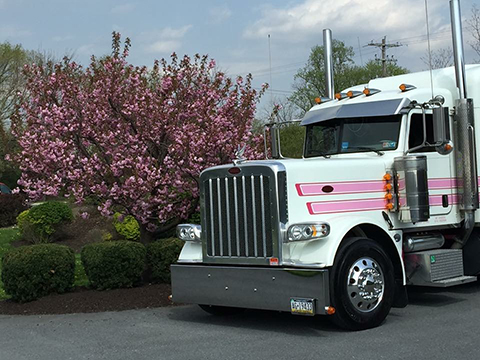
[450, 0, 479, 247]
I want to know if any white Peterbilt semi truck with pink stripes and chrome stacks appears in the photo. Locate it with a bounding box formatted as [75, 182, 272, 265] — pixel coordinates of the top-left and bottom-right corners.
[171, 0, 480, 330]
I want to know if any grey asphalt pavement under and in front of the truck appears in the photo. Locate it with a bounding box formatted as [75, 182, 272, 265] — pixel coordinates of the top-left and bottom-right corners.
[0, 282, 480, 360]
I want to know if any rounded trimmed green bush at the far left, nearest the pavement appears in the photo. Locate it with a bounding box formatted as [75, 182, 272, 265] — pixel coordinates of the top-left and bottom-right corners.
[2, 244, 75, 302]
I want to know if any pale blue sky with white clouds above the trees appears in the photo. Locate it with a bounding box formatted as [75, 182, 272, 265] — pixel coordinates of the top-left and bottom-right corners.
[0, 0, 480, 112]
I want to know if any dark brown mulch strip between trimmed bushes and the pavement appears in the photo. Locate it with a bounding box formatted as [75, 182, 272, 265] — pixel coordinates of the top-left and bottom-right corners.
[0, 284, 172, 315]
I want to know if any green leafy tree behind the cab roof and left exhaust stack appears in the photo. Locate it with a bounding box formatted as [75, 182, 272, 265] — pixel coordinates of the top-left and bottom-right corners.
[290, 39, 408, 114]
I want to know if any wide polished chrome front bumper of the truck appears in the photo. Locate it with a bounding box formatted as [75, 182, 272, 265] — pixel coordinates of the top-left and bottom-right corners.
[171, 264, 330, 314]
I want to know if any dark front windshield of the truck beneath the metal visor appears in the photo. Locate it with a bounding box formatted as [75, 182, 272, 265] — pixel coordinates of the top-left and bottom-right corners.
[305, 115, 402, 157]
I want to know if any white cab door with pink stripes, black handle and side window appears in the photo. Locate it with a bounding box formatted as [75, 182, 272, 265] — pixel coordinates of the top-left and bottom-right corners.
[407, 109, 458, 216]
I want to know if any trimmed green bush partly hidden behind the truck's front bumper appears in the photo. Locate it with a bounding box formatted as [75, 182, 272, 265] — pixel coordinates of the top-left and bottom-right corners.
[147, 238, 184, 283]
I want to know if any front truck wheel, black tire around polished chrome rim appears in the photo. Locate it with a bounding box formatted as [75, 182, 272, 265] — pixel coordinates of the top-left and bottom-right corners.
[330, 238, 395, 330]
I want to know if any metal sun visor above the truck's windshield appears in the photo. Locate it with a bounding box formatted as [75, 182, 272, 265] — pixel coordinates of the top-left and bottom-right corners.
[301, 98, 410, 125]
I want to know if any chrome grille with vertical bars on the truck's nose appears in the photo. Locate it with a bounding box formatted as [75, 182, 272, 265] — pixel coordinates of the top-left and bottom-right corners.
[203, 174, 274, 258]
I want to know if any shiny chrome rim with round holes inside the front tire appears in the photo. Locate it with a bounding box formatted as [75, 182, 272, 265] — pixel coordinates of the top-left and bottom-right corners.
[347, 257, 385, 312]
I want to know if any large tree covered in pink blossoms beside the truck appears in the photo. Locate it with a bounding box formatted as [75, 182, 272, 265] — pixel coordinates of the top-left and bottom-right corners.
[11, 33, 264, 236]
